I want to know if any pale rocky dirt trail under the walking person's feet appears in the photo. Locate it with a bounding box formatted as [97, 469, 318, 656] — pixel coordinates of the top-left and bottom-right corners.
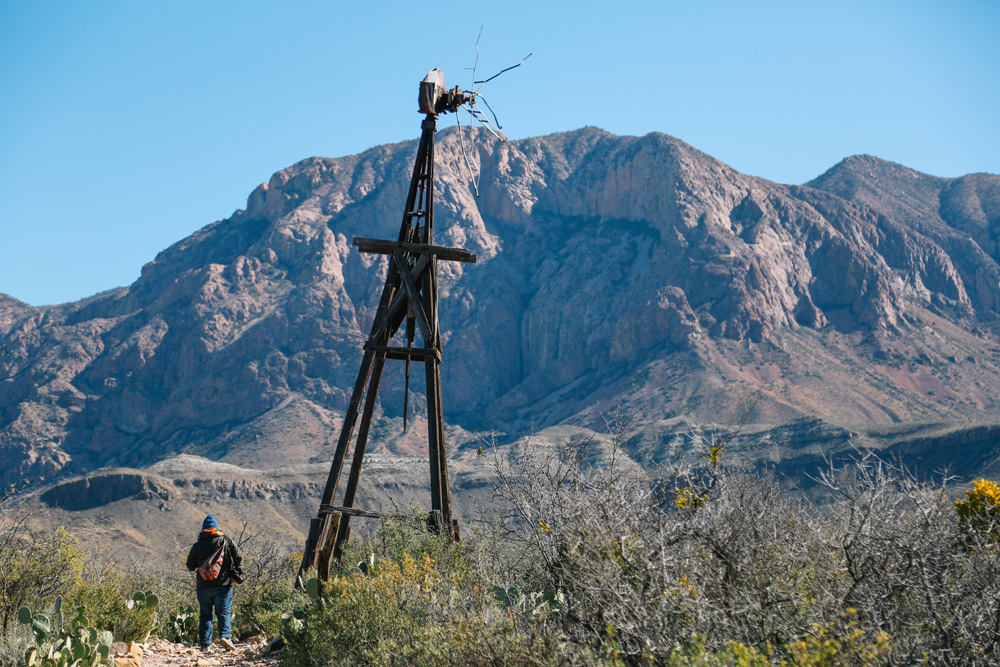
[125, 638, 279, 667]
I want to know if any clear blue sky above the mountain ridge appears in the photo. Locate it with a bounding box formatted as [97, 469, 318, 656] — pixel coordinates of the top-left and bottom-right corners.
[0, 0, 1000, 305]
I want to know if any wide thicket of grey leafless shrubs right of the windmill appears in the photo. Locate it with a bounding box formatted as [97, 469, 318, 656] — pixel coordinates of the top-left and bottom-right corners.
[493, 420, 1000, 665]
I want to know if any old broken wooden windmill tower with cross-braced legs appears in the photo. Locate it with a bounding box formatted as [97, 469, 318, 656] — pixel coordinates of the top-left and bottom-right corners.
[298, 69, 477, 584]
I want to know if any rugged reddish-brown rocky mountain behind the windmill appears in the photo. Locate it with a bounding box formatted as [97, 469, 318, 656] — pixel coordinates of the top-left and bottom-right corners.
[0, 128, 1000, 483]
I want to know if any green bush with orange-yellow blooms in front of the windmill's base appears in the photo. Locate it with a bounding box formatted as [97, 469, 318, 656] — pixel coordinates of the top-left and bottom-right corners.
[284, 548, 564, 667]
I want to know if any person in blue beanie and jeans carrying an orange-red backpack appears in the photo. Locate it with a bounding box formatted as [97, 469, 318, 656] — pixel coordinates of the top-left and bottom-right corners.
[187, 514, 243, 651]
